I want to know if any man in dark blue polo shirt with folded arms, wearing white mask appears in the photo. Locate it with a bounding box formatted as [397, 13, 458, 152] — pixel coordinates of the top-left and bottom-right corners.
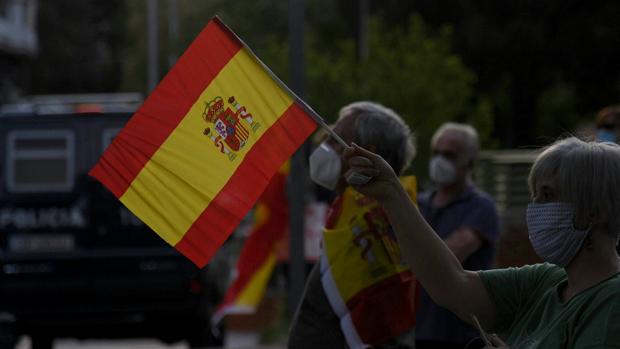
[416, 122, 499, 349]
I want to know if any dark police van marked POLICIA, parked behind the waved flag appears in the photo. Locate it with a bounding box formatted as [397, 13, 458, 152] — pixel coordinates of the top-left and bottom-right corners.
[0, 94, 223, 348]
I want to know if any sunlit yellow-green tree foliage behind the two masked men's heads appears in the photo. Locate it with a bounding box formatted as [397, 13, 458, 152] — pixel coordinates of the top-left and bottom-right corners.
[307, 16, 495, 177]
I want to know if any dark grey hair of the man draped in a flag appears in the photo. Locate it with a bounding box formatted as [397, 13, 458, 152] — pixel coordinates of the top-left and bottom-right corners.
[338, 101, 416, 174]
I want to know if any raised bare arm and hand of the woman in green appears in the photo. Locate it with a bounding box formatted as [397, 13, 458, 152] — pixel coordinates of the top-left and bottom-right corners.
[344, 145, 494, 327]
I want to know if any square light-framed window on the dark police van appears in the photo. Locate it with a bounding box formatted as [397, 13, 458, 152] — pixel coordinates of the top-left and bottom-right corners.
[6, 130, 75, 193]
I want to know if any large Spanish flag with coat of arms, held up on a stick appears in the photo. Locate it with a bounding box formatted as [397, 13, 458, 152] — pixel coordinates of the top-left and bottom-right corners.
[90, 17, 322, 266]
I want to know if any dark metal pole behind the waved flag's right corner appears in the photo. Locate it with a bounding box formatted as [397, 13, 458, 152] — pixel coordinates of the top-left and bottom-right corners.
[288, 0, 308, 317]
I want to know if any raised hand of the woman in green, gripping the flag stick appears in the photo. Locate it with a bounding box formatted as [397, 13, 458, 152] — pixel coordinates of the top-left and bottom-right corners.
[343, 143, 401, 202]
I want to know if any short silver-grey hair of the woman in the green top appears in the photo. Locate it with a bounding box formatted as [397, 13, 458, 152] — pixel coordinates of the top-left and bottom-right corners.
[528, 137, 620, 237]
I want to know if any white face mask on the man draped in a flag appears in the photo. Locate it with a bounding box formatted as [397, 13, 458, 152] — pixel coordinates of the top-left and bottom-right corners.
[310, 142, 342, 190]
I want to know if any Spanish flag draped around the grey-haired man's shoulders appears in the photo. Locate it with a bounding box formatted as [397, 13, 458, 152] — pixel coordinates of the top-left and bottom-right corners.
[319, 177, 417, 348]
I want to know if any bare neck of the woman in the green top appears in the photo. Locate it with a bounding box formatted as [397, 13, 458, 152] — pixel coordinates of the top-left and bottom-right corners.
[561, 237, 620, 302]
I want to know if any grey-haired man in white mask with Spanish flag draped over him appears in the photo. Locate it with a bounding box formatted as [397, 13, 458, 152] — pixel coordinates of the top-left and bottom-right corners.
[288, 102, 415, 349]
